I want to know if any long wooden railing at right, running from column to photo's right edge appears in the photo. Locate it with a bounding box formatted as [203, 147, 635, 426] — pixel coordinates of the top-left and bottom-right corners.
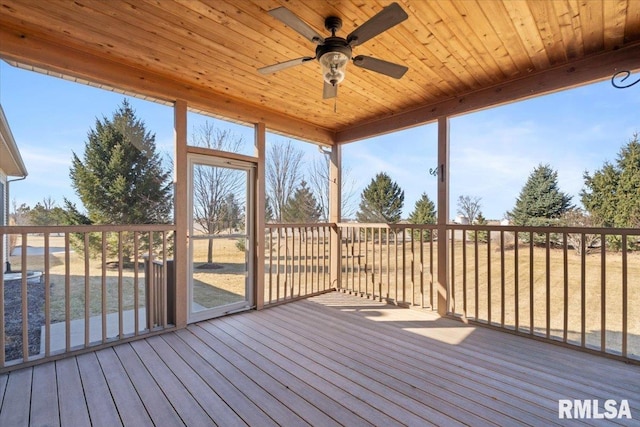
[448, 225, 640, 360]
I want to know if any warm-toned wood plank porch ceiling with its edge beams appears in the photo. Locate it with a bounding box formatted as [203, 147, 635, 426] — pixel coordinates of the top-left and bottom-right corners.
[0, 0, 640, 145]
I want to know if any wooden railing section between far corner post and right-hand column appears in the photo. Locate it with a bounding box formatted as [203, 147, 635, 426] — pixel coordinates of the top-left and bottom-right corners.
[340, 223, 438, 309]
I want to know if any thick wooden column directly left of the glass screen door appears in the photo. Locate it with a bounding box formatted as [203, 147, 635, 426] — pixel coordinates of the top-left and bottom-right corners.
[173, 101, 189, 328]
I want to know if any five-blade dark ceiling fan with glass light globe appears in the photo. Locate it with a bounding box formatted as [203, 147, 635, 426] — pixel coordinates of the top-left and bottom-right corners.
[258, 3, 408, 99]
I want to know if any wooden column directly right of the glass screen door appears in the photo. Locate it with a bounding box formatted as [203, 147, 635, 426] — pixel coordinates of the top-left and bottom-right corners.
[253, 123, 267, 310]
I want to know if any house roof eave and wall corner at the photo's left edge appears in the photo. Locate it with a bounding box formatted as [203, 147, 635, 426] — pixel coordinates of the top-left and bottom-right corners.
[0, 105, 27, 268]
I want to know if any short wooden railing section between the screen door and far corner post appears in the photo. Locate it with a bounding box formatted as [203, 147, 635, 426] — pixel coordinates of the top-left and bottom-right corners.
[264, 223, 331, 305]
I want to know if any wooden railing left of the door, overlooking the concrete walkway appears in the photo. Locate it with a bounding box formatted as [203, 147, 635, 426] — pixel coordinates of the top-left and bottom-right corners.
[0, 225, 175, 371]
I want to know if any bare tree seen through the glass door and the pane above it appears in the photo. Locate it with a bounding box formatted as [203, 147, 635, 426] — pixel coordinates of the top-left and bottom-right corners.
[191, 121, 244, 264]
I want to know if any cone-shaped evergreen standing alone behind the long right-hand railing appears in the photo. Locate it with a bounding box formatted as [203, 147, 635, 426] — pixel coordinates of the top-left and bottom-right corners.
[508, 165, 573, 226]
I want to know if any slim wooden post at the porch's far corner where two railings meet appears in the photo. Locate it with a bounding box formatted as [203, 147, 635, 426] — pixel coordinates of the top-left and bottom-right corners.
[329, 144, 342, 289]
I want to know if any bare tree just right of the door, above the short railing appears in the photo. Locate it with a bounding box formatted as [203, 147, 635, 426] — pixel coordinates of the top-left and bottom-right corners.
[266, 141, 303, 222]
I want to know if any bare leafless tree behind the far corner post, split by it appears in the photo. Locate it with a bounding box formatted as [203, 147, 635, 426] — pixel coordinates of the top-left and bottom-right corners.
[309, 152, 356, 220]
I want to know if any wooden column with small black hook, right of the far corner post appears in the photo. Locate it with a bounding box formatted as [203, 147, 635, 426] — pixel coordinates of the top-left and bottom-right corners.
[437, 117, 451, 316]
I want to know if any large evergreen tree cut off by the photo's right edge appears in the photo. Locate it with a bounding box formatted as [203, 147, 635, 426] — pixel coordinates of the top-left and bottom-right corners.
[580, 133, 640, 227]
